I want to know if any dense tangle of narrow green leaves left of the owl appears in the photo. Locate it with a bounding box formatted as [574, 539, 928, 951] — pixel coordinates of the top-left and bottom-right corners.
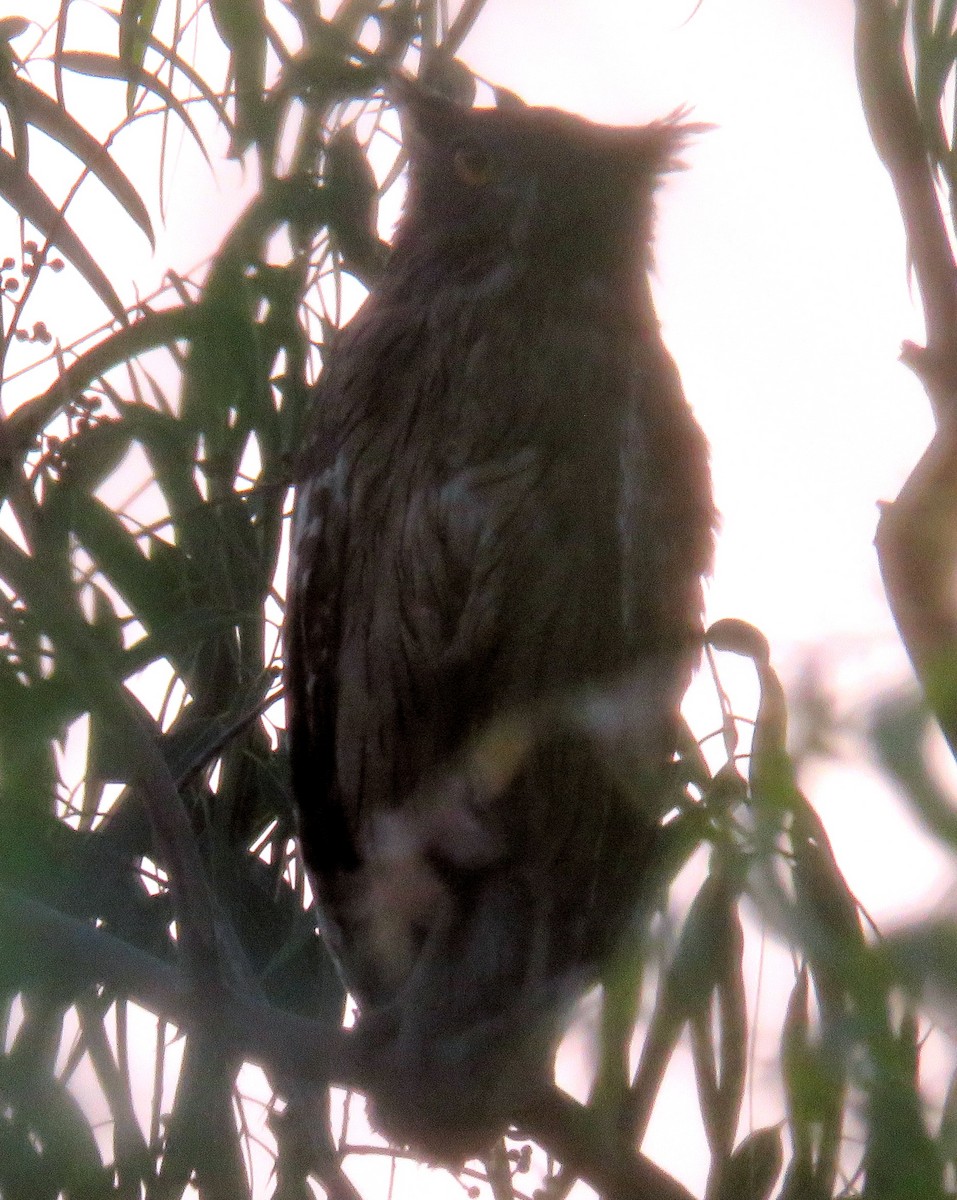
[0, 0, 448, 1198]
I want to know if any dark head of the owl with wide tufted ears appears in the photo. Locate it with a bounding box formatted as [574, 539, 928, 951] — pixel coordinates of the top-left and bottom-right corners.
[393, 79, 704, 279]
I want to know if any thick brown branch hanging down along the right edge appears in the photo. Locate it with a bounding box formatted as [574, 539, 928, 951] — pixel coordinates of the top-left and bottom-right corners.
[855, 0, 957, 755]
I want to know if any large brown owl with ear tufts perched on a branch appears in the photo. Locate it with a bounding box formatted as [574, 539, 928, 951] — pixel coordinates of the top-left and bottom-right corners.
[284, 83, 714, 1163]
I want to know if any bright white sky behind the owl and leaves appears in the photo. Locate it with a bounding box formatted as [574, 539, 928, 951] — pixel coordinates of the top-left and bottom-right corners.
[0, 0, 952, 1183]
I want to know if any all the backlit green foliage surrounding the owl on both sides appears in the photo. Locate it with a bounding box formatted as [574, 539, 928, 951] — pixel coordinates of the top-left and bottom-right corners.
[0, 0, 957, 1200]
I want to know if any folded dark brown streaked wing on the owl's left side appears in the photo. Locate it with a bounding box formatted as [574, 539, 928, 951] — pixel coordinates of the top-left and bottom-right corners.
[284, 314, 506, 878]
